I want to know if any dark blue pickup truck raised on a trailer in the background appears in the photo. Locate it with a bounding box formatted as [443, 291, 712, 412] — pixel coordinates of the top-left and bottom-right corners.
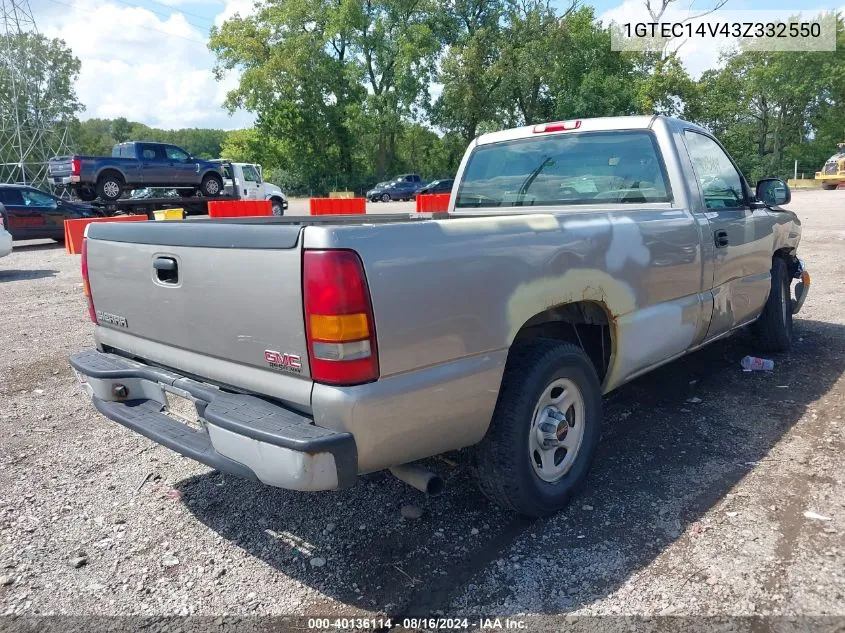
[49, 141, 223, 202]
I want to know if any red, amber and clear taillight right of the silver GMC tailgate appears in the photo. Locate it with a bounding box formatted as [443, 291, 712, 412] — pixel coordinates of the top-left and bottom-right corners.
[302, 250, 378, 385]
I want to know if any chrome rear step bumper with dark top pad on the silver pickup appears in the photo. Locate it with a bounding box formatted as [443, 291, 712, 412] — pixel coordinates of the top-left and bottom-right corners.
[70, 350, 358, 490]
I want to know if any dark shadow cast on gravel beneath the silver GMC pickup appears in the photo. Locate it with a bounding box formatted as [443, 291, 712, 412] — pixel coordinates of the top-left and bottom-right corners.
[179, 320, 845, 617]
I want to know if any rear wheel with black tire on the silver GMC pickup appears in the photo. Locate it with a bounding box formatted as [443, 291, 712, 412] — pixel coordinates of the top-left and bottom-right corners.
[475, 338, 602, 517]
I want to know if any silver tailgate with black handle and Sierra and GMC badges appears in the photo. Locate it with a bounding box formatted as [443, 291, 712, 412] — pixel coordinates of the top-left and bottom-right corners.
[87, 221, 310, 404]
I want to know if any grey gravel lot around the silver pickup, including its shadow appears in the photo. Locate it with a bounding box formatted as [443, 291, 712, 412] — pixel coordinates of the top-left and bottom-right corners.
[0, 191, 845, 630]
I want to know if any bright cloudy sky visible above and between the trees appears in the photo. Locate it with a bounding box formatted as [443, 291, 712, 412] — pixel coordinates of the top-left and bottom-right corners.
[30, 0, 845, 129]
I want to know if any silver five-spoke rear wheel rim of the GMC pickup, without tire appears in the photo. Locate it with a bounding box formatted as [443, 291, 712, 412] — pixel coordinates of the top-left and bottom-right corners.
[528, 378, 584, 483]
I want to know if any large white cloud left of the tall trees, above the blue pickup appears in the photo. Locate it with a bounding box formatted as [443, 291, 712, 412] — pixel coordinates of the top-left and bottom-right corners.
[40, 0, 252, 129]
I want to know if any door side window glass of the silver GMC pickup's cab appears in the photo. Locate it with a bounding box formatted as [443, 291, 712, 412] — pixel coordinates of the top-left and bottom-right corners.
[684, 130, 745, 209]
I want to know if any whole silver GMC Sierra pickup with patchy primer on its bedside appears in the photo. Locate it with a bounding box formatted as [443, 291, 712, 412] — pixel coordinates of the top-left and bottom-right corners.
[71, 117, 809, 516]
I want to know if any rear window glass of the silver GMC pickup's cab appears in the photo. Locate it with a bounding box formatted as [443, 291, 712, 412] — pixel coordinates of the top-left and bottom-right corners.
[455, 131, 672, 208]
